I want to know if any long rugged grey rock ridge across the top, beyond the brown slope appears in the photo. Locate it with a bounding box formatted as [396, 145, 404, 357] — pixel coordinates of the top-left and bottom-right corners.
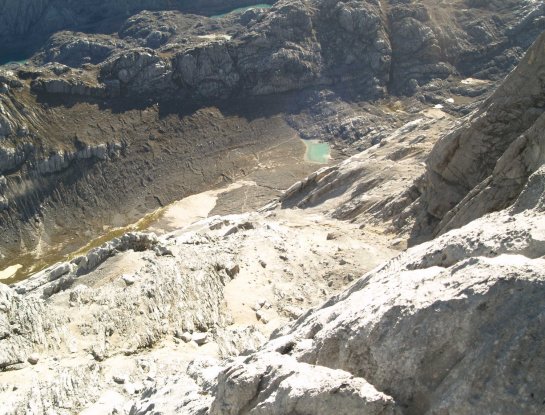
[11, 0, 545, 99]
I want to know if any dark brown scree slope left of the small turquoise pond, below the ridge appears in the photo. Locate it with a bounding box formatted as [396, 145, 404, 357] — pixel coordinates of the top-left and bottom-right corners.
[0, 84, 306, 272]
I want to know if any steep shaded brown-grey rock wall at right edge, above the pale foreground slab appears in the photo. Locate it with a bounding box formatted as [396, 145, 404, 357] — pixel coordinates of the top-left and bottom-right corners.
[422, 29, 545, 233]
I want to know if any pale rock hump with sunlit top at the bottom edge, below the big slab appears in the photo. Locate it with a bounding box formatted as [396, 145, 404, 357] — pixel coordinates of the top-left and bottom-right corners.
[209, 353, 398, 415]
